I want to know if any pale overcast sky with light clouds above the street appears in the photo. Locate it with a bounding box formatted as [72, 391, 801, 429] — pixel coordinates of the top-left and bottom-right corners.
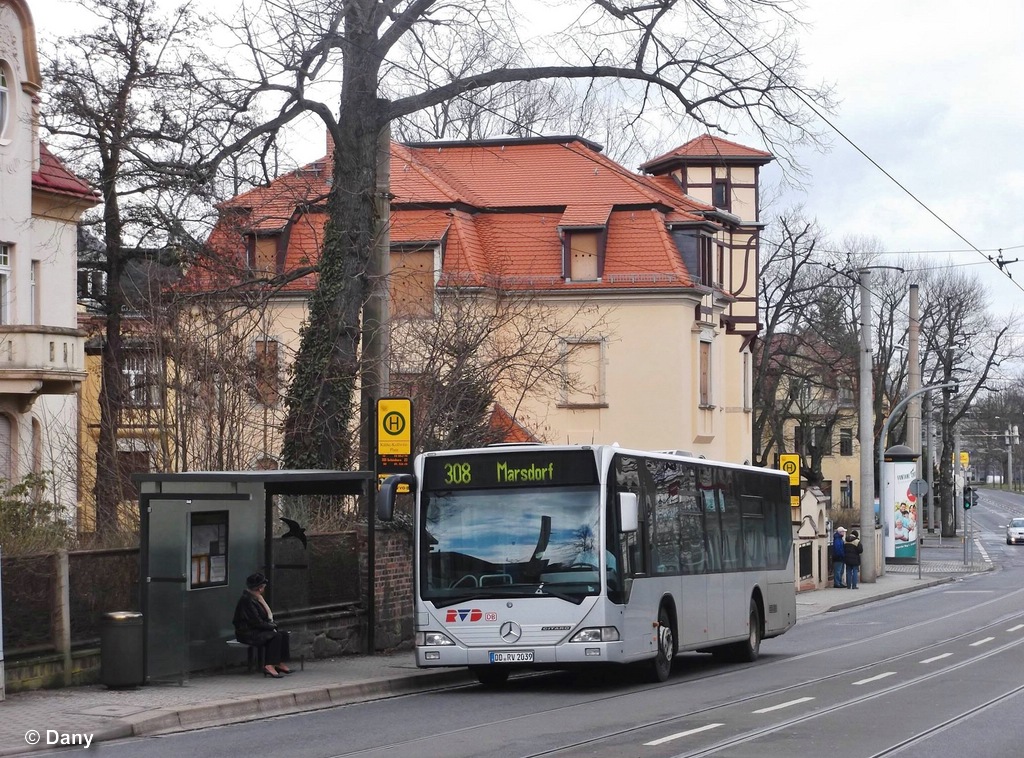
[29, 0, 1024, 310]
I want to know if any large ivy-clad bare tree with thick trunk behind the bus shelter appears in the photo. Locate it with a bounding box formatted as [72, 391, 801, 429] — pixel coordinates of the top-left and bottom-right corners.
[203, 0, 829, 468]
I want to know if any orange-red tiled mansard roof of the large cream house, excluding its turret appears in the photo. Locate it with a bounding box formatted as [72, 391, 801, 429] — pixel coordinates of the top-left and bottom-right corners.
[203, 137, 756, 290]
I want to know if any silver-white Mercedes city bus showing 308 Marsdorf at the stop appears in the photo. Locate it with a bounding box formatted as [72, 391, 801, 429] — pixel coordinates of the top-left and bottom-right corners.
[377, 445, 797, 684]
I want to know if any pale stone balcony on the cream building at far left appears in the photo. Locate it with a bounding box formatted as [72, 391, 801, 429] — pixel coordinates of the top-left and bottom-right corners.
[0, 324, 86, 408]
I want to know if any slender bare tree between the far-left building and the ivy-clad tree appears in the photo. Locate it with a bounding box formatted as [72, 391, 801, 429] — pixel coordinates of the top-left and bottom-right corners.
[41, 0, 268, 533]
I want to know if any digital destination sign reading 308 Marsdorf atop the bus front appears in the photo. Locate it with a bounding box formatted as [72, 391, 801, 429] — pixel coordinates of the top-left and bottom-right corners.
[423, 450, 598, 490]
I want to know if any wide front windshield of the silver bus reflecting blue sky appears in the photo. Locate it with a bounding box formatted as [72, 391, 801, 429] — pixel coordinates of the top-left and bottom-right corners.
[420, 487, 613, 606]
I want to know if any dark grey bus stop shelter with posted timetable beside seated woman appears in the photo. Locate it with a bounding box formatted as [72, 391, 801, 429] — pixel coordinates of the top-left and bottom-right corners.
[132, 470, 376, 682]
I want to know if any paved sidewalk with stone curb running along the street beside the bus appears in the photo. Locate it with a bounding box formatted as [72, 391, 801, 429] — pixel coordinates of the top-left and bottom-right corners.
[0, 543, 991, 756]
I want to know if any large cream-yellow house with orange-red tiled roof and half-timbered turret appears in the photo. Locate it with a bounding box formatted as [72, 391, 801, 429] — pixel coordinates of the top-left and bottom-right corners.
[191, 135, 772, 462]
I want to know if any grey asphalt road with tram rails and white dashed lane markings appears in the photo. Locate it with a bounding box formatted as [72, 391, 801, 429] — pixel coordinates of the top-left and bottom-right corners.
[58, 492, 1024, 758]
